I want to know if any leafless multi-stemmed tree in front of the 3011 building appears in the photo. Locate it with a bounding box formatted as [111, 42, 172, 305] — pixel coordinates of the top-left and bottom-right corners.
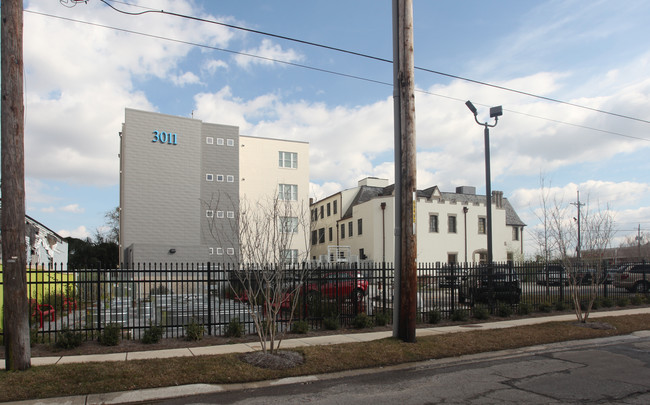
[204, 193, 310, 354]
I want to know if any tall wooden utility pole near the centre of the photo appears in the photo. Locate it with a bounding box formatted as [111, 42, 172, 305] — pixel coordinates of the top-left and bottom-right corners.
[393, 0, 417, 342]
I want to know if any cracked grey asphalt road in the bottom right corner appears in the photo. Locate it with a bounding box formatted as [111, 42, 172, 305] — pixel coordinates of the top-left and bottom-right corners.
[156, 331, 650, 405]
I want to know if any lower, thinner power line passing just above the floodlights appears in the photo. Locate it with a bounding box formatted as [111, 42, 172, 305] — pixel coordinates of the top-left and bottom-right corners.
[24, 10, 650, 142]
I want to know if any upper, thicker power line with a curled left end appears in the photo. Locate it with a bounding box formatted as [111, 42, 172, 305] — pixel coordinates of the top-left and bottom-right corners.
[100, 0, 650, 124]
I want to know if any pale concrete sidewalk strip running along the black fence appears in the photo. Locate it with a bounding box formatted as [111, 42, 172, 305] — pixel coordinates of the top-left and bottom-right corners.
[5, 308, 650, 370]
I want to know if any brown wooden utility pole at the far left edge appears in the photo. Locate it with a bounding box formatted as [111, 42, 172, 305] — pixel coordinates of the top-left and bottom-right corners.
[0, 0, 31, 370]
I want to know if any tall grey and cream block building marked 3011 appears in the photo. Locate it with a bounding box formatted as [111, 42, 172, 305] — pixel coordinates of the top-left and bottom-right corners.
[119, 109, 309, 265]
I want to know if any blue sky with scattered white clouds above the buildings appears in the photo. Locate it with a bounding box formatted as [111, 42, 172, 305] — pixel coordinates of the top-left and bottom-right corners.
[8, 0, 650, 256]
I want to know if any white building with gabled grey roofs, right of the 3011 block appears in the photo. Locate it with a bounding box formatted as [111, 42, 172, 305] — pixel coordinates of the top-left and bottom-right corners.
[311, 178, 525, 263]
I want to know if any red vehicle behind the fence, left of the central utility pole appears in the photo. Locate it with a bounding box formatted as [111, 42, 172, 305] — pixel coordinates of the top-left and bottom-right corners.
[306, 271, 368, 301]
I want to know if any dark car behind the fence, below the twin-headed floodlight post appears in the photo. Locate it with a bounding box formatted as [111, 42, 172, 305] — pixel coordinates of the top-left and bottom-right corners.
[458, 264, 521, 305]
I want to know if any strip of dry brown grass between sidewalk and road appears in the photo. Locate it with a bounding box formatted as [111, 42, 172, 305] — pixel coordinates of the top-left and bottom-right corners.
[0, 315, 650, 401]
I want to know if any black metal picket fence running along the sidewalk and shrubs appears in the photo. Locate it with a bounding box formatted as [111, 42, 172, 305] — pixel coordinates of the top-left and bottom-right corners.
[0, 263, 650, 342]
